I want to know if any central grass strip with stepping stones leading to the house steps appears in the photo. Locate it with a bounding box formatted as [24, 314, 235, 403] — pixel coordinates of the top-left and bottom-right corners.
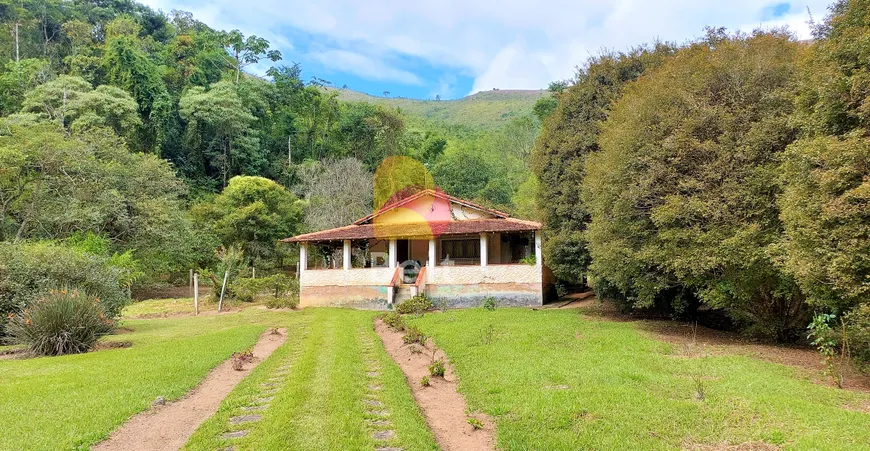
[186, 309, 438, 451]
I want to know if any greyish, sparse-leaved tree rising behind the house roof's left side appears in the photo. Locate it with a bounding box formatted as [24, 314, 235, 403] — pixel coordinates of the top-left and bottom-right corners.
[304, 158, 373, 230]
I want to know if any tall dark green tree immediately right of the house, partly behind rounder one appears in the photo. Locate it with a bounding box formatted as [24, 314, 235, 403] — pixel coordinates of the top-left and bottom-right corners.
[531, 44, 674, 283]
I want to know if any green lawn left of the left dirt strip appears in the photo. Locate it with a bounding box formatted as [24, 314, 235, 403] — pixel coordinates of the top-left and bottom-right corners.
[0, 309, 292, 450]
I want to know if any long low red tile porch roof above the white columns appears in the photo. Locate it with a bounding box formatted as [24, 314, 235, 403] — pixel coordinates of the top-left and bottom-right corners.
[281, 218, 541, 243]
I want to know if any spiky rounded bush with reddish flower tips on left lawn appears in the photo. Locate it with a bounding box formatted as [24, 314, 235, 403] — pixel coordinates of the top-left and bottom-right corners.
[6, 289, 114, 355]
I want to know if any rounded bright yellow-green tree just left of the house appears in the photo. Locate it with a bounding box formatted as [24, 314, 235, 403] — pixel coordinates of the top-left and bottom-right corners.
[194, 176, 304, 261]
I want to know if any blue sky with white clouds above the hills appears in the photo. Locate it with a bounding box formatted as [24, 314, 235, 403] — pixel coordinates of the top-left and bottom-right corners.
[140, 0, 833, 99]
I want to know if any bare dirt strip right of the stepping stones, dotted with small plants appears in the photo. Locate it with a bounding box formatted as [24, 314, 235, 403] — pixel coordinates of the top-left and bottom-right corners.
[375, 319, 495, 451]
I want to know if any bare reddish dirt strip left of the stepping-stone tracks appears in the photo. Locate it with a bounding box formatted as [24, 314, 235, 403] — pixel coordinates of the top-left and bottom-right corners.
[92, 329, 287, 451]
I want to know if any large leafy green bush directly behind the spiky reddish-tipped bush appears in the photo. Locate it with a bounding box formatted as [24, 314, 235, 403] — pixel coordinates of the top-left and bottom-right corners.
[0, 242, 129, 336]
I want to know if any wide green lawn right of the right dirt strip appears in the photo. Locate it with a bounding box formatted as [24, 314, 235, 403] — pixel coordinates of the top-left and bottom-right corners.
[410, 309, 870, 450]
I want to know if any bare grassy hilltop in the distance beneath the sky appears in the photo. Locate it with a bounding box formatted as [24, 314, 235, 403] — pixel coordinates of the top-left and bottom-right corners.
[334, 89, 550, 131]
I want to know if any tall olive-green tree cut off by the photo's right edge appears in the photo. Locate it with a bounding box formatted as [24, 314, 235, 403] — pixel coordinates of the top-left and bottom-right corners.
[780, 0, 870, 316]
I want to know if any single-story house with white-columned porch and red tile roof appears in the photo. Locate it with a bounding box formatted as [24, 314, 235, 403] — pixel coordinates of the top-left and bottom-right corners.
[282, 189, 552, 309]
